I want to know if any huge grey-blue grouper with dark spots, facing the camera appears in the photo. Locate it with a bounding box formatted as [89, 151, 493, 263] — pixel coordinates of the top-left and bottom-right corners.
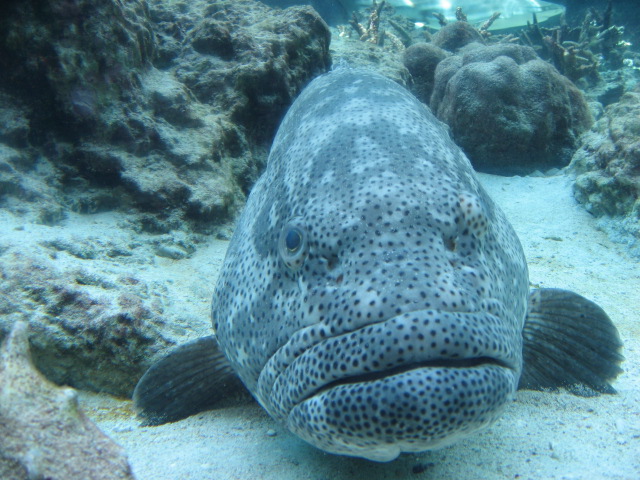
[134, 67, 623, 461]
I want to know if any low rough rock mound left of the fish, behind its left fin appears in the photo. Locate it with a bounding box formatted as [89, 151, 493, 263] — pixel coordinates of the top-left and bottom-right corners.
[0, 249, 172, 396]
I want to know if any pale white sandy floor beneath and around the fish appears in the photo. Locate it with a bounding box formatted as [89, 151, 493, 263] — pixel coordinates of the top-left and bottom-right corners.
[77, 175, 640, 480]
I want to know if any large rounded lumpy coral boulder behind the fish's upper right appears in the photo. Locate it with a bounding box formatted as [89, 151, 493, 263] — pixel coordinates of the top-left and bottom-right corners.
[430, 44, 592, 173]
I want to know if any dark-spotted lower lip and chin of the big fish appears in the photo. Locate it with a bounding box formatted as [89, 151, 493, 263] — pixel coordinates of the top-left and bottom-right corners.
[287, 363, 517, 462]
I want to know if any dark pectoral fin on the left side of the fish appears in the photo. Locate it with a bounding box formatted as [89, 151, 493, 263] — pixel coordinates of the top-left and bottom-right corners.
[133, 336, 246, 425]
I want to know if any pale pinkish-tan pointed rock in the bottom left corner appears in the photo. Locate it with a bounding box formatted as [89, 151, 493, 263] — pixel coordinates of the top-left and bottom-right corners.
[0, 322, 134, 480]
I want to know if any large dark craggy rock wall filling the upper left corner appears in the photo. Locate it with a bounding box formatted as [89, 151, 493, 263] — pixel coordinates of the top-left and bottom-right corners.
[0, 0, 330, 232]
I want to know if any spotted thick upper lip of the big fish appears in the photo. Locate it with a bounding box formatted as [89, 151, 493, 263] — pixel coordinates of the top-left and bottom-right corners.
[258, 310, 522, 420]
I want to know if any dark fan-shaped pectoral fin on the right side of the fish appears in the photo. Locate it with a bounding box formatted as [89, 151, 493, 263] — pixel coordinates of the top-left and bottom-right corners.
[518, 288, 624, 396]
